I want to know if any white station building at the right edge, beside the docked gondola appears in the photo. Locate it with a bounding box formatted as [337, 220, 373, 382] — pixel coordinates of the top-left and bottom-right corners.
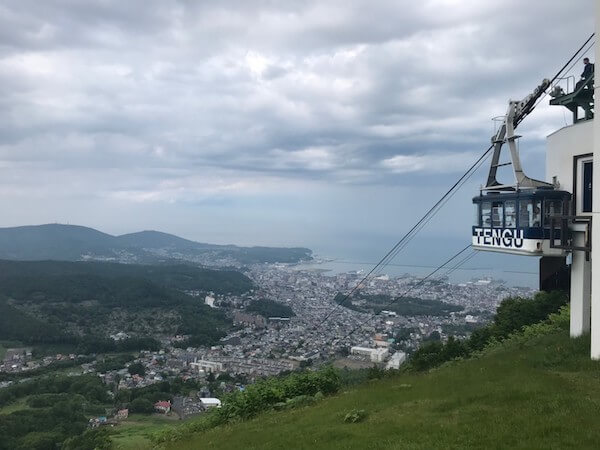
[546, 26, 600, 359]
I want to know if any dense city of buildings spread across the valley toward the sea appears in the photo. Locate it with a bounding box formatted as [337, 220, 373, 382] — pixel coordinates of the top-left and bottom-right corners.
[0, 264, 534, 424]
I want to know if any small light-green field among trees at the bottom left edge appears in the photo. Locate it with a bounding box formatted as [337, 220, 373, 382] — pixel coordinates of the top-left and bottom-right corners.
[111, 414, 180, 450]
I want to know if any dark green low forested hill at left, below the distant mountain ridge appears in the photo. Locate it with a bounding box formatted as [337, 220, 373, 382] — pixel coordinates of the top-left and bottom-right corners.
[0, 261, 254, 353]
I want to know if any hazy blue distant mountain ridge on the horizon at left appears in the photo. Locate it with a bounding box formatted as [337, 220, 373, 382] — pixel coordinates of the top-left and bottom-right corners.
[0, 224, 312, 265]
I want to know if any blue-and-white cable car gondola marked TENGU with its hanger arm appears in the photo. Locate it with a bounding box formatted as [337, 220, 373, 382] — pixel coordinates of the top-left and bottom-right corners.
[472, 80, 571, 256]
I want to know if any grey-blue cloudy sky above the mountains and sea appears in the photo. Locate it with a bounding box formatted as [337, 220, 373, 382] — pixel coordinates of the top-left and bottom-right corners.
[0, 0, 593, 261]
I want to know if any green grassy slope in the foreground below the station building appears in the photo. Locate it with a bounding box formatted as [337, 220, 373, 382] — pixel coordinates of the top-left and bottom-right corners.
[167, 331, 600, 450]
